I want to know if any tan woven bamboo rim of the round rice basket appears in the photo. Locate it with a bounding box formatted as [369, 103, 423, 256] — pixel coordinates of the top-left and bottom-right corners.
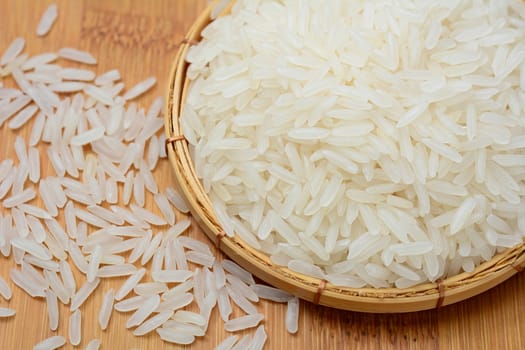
[165, 4, 525, 313]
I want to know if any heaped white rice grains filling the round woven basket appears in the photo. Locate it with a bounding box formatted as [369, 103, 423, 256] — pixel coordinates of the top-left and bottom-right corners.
[182, 0, 525, 288]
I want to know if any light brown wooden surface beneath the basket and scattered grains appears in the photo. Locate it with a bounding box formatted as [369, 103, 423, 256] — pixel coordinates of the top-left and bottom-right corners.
[0, 0, 525, 350]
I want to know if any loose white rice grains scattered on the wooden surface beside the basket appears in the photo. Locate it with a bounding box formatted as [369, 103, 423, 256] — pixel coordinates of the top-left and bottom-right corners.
[0, 5, 299, 350]
